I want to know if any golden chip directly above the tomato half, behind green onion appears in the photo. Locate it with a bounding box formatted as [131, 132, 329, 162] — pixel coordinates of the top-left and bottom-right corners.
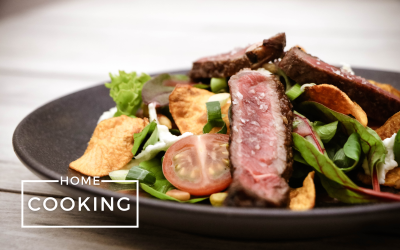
[169, 85, 231, 135]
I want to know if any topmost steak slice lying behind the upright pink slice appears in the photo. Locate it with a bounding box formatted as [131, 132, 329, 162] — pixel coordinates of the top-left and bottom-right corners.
[189, 33, 286, 79]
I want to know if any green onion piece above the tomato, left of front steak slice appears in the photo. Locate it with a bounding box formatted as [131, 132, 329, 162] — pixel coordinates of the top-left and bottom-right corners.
[203, 102, 228, 134]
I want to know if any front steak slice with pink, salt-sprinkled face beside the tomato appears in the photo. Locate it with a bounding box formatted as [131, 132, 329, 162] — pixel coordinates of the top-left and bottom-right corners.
[225, 69, 293, 207]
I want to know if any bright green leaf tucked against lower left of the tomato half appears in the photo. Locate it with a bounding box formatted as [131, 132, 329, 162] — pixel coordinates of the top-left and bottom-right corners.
[139, 158, 208, 203]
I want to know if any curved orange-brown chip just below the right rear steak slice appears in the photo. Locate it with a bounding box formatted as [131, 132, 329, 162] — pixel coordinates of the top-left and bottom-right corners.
[302, 84, 368, 127]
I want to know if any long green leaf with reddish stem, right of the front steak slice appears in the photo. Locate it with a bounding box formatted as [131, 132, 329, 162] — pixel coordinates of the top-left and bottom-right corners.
[292, 133, 400, 203]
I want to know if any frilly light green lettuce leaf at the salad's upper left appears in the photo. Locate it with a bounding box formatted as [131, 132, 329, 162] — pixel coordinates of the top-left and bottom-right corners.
[105, 71, 151, 117]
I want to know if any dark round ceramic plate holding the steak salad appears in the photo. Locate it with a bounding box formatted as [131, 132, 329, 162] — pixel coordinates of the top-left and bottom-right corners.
[13, 69, 400, 239]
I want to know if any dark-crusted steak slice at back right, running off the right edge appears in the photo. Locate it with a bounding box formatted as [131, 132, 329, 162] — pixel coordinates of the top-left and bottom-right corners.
[279, 47, 400, 123]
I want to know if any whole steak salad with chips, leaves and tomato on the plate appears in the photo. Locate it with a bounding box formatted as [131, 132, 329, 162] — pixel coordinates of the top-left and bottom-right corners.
[70, 33, 400, 210]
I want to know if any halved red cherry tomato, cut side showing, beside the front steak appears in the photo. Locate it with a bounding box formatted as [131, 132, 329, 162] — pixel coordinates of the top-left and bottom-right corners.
[163, 134, 232, 196]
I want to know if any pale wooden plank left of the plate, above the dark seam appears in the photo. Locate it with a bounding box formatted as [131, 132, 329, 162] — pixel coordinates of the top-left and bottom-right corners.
[0, 74, 100, 196]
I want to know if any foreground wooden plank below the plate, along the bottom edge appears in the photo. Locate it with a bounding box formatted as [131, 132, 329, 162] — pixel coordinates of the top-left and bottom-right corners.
[0, 192, 399, 250]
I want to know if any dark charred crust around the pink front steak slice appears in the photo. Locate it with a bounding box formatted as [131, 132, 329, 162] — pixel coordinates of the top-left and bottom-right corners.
[225, 69, 293, 207]
